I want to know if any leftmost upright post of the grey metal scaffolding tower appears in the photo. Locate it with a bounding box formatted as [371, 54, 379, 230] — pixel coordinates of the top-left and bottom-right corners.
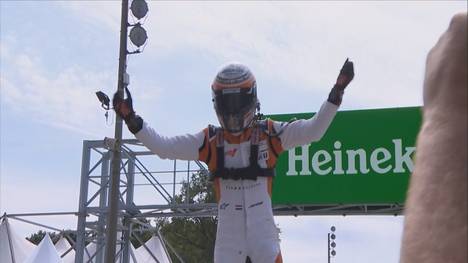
[75, 141, 91, 263]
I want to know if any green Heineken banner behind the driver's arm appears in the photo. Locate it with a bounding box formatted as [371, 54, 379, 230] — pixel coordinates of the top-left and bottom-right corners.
[269, 107, 421, 205]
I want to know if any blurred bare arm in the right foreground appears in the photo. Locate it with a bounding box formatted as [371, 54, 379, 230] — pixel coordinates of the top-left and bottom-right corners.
[400, 13, 468, 263]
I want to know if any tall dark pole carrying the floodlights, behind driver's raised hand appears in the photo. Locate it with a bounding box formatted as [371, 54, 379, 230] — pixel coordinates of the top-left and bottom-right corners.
[106, 0, 128, 263]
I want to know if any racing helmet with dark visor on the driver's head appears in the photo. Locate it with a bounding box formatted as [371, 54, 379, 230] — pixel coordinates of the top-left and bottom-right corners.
[211, 63, 260, 133]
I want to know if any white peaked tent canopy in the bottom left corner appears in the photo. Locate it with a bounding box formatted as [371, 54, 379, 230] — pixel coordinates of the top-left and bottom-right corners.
[0, 218, 36, 263]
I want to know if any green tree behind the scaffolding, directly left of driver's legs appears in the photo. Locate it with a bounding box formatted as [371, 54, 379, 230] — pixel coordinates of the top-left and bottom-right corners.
[158, 172, 217, 263]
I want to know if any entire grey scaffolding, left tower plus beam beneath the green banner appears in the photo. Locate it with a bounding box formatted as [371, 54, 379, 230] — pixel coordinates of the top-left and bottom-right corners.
[71, 139, 402, 262]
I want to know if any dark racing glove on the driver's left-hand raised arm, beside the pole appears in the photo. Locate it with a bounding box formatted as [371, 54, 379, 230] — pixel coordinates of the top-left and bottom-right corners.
[112, 87, 143, 134]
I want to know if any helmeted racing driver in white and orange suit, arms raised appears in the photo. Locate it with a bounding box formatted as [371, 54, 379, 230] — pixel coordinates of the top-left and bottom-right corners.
[113, 59, 354, 263]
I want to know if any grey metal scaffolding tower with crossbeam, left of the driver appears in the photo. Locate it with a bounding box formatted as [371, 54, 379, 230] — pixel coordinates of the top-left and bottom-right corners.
[75, 139, 216, 262]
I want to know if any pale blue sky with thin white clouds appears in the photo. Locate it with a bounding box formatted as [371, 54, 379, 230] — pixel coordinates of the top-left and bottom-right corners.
[0, 1, 466, 262]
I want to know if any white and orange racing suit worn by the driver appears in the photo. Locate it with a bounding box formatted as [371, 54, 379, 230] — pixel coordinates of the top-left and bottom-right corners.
[135, 102, 338, 263]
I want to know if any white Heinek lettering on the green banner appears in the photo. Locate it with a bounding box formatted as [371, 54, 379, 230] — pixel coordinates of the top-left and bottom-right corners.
[286, 139, 416, 176]
